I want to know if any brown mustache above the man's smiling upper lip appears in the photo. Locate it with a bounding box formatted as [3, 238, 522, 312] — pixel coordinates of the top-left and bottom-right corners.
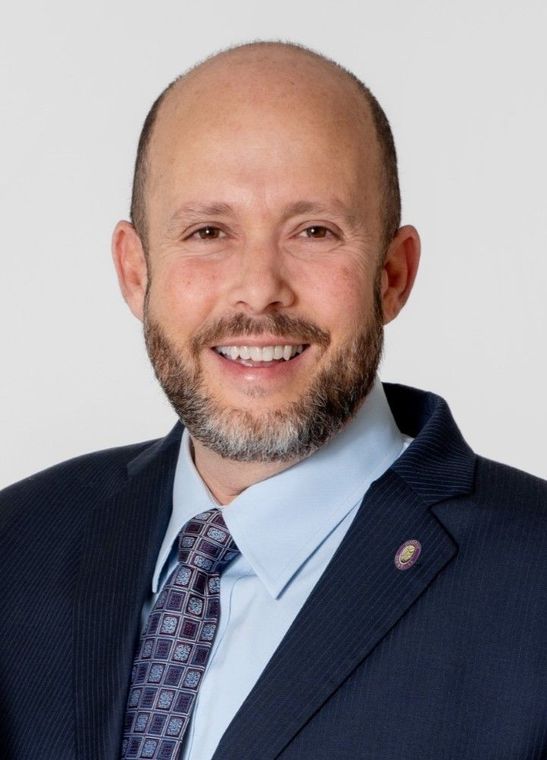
[191, 314, 331, 354]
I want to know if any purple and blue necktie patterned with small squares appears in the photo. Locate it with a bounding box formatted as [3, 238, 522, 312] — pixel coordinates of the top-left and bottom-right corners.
[121, 509, 239, 760]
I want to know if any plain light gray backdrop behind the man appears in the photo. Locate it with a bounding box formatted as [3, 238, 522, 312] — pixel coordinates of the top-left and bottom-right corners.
[0, 0, 547, 485]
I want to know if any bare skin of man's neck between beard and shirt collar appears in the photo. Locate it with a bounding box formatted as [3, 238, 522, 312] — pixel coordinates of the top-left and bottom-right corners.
[192, 438, 298, 505]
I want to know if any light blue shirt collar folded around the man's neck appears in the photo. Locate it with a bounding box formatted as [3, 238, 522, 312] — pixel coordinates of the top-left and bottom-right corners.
[153, 380, 405, 597]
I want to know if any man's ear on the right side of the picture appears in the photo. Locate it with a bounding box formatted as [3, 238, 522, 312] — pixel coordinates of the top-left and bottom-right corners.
[382, 224, 420, 325]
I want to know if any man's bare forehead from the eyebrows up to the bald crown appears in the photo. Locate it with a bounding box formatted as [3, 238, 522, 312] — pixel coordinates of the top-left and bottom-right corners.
[148, 50, 379, 217]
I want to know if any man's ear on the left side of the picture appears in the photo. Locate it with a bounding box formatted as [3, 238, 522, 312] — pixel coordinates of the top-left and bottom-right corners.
[112, 221, 148, 322]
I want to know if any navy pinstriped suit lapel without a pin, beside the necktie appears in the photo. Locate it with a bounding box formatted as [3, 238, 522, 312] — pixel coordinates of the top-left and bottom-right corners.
[73, 426, 180, 760]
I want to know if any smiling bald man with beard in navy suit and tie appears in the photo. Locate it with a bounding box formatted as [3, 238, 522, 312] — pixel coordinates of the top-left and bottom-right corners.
[0, 43, 547, 760]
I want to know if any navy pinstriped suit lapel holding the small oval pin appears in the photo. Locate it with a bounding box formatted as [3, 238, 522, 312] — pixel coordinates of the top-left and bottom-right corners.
[214, 388, 474, 760]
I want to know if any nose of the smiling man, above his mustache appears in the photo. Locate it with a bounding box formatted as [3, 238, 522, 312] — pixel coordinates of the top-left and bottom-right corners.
[229, 241, 296, 314]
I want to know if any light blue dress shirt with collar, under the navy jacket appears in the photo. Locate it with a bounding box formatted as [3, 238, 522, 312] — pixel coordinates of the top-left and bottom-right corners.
[143, 380, 410, 760]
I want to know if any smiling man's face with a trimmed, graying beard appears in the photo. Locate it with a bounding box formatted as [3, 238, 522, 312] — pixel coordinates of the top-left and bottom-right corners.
[122, 60, 400, 461]
